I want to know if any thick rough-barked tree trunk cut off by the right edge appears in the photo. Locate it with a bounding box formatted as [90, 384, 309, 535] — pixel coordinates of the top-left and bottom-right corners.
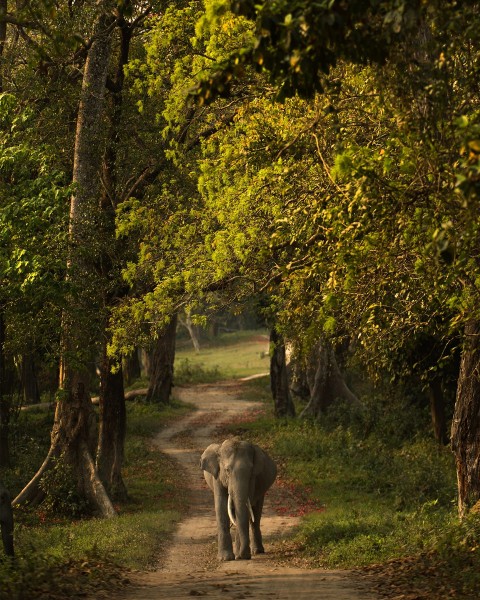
[451, 321, 480, 517]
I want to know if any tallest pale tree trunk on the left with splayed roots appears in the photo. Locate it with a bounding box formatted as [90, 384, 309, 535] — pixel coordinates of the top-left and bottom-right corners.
[14, 8, 115, 517]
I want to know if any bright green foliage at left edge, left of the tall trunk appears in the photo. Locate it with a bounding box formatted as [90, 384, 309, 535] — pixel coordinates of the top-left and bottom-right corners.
[0, 93, 71, 353]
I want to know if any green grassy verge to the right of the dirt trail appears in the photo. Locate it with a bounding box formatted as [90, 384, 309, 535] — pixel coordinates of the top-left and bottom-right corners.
[229, 380, 480, 600]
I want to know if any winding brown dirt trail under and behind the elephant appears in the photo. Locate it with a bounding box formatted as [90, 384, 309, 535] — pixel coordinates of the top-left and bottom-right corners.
[110, 381, 378, 600]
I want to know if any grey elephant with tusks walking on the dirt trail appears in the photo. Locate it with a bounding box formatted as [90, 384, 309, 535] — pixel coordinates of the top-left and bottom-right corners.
[200, 437, 277, 561]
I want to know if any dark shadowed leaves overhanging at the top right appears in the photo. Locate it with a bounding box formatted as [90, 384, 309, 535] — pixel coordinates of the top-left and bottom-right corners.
[193, 0, 475, 101]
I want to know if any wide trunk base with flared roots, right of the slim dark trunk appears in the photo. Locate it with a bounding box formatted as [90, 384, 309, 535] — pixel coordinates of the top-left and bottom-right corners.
[300, 342, 359, 418]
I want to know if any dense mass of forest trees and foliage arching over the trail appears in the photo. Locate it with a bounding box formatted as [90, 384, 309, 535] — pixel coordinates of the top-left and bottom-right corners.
[0, 0, 480, 596]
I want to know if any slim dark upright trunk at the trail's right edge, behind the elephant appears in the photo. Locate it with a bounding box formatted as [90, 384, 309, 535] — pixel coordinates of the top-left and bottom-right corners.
[270, 328, 295, 417]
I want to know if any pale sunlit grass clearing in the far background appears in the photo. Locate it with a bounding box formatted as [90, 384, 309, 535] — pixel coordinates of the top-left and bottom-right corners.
[175, 330, 270, 384]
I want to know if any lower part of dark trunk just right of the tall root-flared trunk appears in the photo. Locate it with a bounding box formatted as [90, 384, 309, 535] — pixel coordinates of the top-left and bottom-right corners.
[96, 347, 127, 500]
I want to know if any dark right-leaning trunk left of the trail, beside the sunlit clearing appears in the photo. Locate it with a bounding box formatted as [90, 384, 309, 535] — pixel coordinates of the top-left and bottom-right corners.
[147, 314, 177, 404]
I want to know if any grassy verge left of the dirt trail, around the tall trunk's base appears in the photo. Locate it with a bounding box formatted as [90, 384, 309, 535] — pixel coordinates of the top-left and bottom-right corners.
[0, 403, 190, 600]
